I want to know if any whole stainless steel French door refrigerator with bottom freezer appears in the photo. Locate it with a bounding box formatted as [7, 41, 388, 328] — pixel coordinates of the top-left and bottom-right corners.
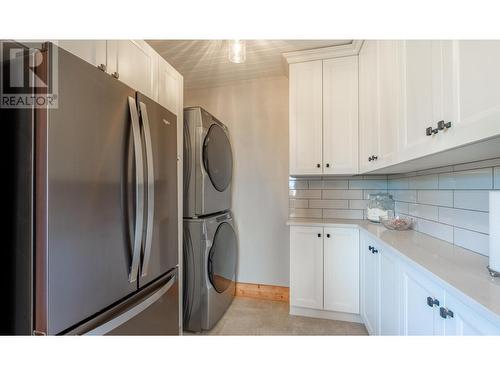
[1, 43, 179, 335]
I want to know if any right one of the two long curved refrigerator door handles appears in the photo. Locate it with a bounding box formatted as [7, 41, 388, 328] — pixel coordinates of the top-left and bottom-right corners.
[139, 102, 155, 277]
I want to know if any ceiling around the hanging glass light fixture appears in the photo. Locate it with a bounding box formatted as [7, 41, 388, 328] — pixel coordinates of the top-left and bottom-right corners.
[147, 40, 352, 90]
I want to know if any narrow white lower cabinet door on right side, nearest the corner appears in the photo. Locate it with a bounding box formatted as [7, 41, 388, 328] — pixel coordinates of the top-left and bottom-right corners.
[359, 237, 380, 335]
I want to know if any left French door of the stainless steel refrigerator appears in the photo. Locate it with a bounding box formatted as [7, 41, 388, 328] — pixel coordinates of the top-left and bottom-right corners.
[35, 46, 143, 334]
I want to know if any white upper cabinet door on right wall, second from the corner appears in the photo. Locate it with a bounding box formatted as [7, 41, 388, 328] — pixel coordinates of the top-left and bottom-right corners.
[372, 40, 402, 168]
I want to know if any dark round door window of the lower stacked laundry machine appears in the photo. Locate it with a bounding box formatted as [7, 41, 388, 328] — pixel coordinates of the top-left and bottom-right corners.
[208, 223, 238, 293]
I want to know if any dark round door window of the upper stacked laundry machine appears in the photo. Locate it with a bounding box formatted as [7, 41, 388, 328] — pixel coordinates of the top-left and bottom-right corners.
[203, 124, 233, 192]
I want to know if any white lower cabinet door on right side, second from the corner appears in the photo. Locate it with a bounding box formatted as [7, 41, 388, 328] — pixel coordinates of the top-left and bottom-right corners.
[380, 249, 401, 336]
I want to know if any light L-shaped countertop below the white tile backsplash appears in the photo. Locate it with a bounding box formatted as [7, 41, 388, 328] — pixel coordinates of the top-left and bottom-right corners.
[287, 218, 500, 323]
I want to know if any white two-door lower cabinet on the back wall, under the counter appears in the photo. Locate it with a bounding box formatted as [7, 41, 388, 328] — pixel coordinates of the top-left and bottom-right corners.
[290, 225, 359, 321]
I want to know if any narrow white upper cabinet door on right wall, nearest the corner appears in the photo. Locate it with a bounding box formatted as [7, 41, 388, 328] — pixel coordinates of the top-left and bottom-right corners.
[359, 40, 379, 173]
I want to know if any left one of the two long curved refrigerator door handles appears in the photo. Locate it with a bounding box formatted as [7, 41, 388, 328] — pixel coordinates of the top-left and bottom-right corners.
[128, 96, 144, 283]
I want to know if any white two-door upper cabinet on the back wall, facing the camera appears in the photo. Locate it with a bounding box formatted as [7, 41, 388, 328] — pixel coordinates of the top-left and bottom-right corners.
[289, 56, 358, 175]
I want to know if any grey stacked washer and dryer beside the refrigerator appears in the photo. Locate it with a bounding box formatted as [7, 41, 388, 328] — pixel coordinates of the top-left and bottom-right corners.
[183, 107, 238, 332]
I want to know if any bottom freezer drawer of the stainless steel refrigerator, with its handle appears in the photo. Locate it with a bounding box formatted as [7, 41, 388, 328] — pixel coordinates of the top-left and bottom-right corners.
[69, 269, 179, 335]
